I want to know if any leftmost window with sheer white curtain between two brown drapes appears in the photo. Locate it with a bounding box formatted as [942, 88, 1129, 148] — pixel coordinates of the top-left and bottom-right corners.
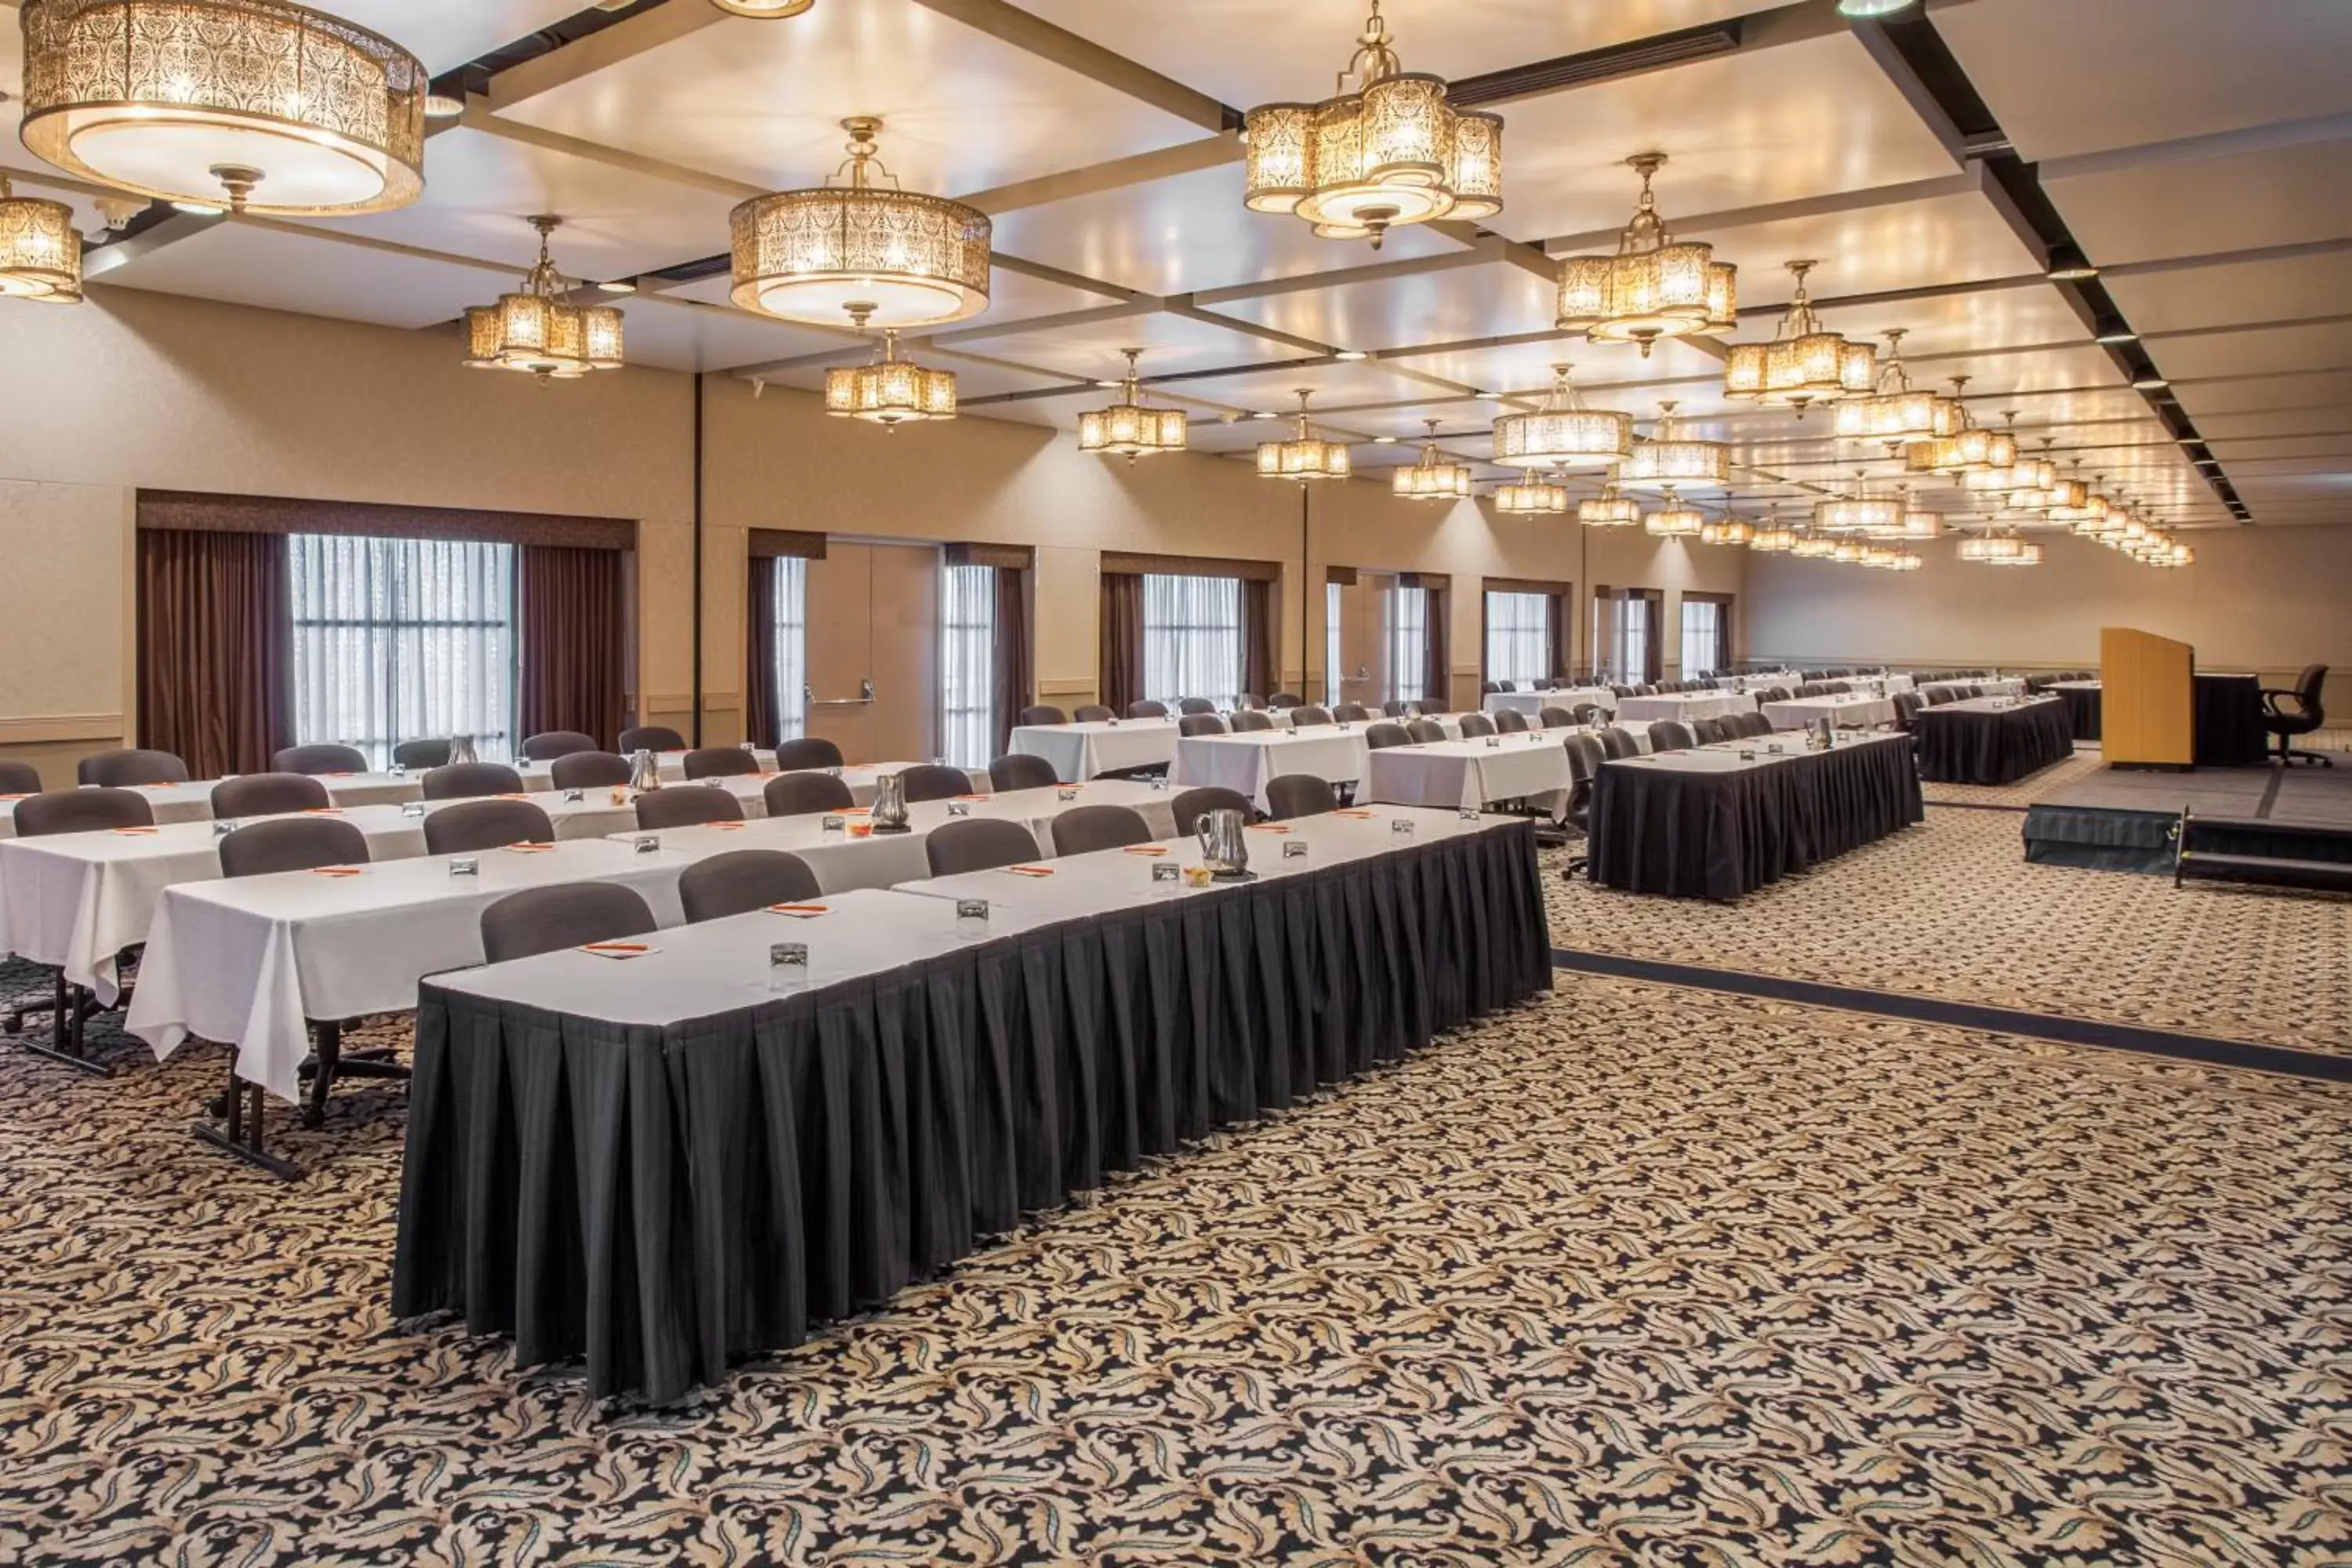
[287, 534, 517, 769]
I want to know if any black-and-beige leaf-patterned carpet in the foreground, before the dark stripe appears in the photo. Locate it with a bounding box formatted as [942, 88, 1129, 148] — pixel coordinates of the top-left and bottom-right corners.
[0, 973, 2352, 1568]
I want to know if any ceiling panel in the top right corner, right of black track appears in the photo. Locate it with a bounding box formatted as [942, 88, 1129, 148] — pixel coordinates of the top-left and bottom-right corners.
[1936, 0, 2352, 162]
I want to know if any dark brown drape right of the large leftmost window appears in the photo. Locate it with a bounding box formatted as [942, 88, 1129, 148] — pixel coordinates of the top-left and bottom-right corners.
[515, 546, 628, 746]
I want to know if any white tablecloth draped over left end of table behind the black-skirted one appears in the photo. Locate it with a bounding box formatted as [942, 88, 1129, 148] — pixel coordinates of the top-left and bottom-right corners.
[129, 839, 689, 1100]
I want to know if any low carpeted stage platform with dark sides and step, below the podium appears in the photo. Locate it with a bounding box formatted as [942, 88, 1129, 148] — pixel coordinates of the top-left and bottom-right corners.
[2025, 767, 2352, 874]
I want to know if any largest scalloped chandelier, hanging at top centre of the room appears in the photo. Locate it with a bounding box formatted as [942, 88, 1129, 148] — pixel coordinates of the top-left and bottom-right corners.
[1242, 0, 1503, 249]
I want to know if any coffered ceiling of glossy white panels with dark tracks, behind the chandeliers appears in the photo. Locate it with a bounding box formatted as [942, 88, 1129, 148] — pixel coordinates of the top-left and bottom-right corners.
[0, 0, 2352, 527]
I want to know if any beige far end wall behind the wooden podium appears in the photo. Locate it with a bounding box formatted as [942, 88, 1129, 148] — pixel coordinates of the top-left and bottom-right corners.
[1748, 524, 2352, 713]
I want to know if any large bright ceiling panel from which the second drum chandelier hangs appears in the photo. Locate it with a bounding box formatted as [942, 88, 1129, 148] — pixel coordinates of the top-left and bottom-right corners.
[501, 0, 1204, 195]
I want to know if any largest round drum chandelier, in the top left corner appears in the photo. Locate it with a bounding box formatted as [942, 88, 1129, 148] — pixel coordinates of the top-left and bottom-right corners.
[21, 0, 428, 216]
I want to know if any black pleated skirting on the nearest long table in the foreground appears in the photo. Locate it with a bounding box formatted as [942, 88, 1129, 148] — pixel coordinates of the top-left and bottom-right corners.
[393, 822, 1552, 1401]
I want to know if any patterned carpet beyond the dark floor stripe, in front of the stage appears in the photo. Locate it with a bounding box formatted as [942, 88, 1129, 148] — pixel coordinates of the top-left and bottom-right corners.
[1543, 808, 2352, 1053]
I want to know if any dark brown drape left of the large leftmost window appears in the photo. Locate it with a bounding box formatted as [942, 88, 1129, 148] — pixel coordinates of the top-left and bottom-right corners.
[139, 529, 294, 779]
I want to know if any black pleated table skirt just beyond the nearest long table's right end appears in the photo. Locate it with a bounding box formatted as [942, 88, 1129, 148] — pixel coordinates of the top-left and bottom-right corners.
[1588, 736, 1926, 898]
